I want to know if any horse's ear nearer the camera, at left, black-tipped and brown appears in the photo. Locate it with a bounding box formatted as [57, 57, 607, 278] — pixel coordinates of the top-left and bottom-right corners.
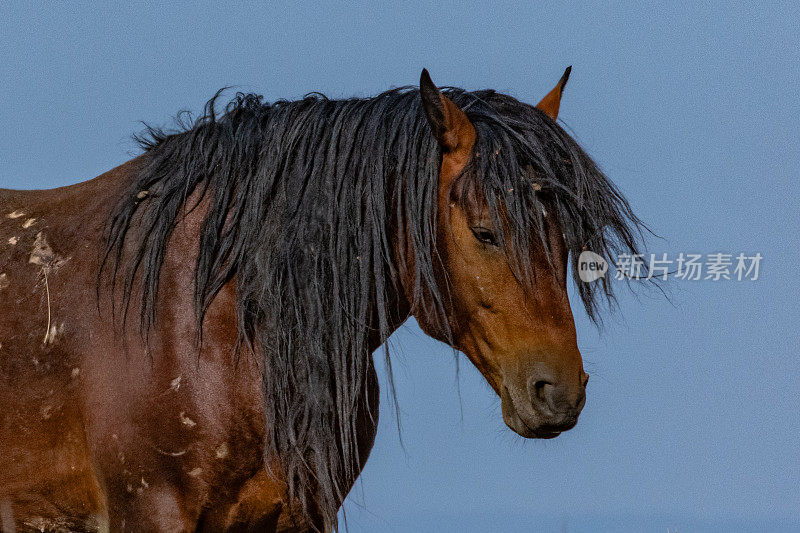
[419, 69, 475, 152]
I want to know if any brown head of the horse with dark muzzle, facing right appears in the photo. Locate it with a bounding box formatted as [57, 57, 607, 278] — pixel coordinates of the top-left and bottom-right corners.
[415, 71, 589, 438]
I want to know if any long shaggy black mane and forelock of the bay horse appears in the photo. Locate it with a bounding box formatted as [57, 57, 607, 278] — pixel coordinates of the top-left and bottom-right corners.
[106, 88, 639, 524]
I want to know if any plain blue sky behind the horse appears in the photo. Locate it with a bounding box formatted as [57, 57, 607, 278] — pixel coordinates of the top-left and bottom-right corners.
[0, 1, 800, 532]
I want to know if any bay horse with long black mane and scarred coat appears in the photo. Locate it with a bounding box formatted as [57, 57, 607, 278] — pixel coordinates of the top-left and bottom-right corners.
[0, 69, 640, 532]
